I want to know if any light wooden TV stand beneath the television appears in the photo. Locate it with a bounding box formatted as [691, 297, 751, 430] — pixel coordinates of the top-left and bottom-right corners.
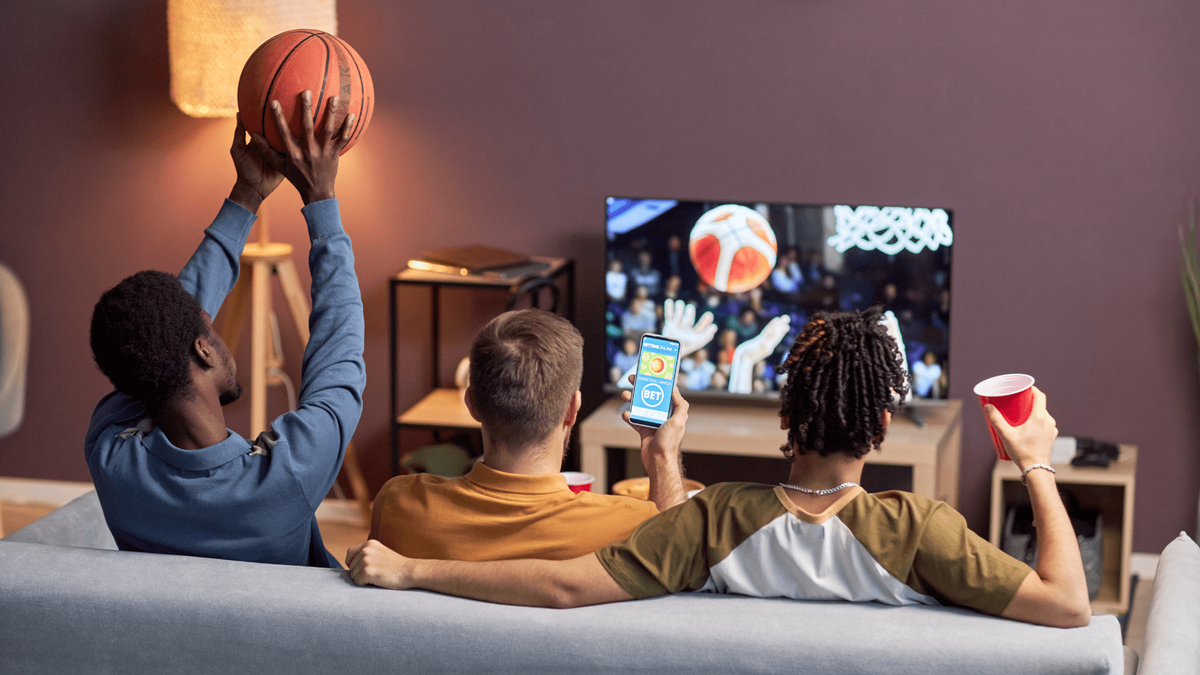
[580, 396, 962, 507]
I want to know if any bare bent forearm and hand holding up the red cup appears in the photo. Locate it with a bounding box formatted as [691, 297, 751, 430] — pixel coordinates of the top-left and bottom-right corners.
[985, 388, 1092, 628]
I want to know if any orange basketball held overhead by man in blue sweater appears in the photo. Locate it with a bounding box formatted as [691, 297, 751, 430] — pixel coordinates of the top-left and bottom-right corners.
[238, 29, 374, 155]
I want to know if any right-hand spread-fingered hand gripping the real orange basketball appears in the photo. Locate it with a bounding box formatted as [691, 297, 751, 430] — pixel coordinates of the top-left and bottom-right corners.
[253, 91, 354, 204]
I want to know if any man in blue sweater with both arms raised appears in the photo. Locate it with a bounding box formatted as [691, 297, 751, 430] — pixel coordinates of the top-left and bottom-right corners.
[84, 92, 366, 568]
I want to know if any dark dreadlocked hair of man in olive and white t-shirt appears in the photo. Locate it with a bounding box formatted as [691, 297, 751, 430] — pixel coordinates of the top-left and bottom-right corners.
[779, 305, 908, 459]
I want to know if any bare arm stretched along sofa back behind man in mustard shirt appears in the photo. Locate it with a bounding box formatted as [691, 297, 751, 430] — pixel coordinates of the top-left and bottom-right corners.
[346, 539, 632, 609]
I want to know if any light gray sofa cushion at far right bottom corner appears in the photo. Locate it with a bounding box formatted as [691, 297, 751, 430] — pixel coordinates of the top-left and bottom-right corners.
[1138, 532, 1200, 675]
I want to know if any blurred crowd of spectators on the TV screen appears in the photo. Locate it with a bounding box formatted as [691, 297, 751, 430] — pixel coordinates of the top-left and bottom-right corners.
[605, 237, 949, 399]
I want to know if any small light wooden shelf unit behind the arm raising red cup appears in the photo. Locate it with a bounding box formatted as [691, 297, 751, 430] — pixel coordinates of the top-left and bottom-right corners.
[990, 446, 1138, 614]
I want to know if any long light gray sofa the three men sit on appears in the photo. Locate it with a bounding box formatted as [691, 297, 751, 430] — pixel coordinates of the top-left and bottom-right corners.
[0, 494, 1142, 675]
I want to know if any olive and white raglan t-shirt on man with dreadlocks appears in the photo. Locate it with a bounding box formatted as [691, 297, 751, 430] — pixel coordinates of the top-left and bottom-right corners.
[596, 483, 1031, 615]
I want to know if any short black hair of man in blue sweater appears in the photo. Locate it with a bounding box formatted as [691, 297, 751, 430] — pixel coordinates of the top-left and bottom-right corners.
[91, 270, 210, 417]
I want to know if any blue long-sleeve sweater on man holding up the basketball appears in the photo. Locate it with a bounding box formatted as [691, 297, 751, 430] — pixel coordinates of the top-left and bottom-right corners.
[84, 199, 366, 568]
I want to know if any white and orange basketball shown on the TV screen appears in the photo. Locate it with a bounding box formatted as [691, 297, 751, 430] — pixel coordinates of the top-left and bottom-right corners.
[688, 204, 779, 293]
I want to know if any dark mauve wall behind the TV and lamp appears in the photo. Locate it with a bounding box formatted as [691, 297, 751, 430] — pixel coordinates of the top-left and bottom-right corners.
[0, 0, 1200, 551]
